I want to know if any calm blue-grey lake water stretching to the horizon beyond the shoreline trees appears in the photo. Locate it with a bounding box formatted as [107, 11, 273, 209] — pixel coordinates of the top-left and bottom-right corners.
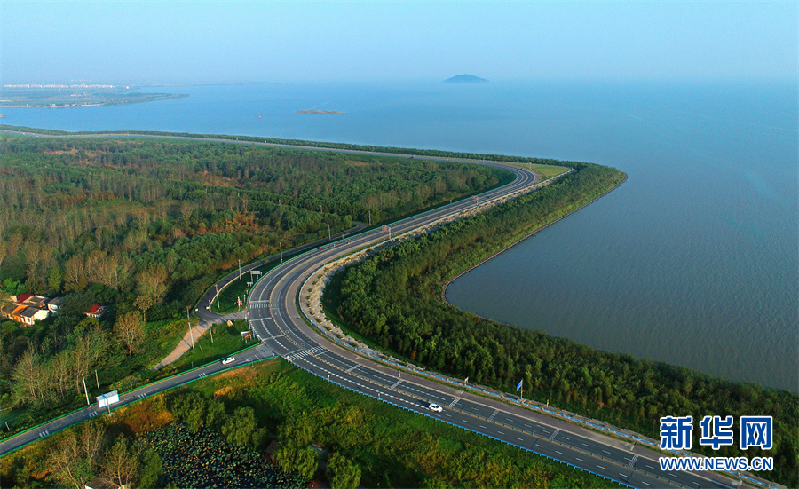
[2, 83, 799, 391]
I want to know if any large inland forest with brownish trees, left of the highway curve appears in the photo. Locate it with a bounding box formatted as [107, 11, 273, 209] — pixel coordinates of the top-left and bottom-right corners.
[0, 135, 512, 426]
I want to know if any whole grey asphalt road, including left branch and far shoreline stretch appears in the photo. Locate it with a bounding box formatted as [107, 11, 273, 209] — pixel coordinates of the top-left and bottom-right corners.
[0, 130, 764, 488]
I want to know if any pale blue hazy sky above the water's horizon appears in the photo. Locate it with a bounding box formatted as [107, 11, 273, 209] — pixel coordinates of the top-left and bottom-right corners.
[0, 0, 799, 84]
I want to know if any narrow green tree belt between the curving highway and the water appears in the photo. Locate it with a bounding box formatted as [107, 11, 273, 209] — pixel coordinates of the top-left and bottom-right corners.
[324, 163, 799, 487]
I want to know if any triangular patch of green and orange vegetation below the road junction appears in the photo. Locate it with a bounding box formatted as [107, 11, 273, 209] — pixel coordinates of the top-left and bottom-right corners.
[0, 360, 618, 489]
